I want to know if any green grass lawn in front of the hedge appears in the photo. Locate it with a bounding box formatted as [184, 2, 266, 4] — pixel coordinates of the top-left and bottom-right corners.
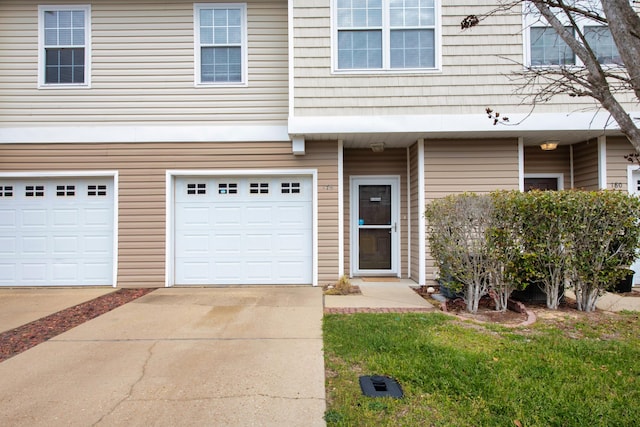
[323, 313, 640, 427]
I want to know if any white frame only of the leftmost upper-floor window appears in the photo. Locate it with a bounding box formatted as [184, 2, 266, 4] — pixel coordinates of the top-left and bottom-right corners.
[38, 4, 91, 89]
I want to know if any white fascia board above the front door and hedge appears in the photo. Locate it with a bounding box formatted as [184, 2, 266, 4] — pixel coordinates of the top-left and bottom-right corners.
[289, 112, 634, 135]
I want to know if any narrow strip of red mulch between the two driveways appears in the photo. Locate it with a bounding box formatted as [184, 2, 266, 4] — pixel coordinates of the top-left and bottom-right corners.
[0, 288, 155, 362]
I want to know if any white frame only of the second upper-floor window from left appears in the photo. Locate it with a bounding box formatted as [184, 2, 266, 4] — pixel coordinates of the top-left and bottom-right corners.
[193, 3, 249, 87]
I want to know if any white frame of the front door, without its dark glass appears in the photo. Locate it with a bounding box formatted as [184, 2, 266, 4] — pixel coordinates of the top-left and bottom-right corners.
[349, 175, 401, 277]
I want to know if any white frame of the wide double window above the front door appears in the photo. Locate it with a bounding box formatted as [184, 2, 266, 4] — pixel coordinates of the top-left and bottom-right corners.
[331, 0, 442, 74]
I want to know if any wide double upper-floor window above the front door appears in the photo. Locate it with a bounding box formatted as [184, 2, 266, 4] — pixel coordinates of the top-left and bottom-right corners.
[334, 0, 439, 71]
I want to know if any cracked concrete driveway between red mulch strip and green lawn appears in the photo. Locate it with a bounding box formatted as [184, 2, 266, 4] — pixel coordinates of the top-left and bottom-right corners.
[0, 287, 325, 426]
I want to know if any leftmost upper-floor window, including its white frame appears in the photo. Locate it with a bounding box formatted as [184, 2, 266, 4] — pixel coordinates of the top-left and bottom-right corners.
[38, 5, 91, 87]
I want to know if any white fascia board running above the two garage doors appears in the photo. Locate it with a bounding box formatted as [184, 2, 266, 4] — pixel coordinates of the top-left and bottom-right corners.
[0, 124, 290, 143]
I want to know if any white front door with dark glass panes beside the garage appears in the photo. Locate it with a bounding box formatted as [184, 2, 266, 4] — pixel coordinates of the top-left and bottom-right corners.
[351, 177, 400, 276]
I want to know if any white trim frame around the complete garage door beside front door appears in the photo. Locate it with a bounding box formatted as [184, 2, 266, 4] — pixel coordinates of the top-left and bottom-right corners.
[164, 169, 318, 287]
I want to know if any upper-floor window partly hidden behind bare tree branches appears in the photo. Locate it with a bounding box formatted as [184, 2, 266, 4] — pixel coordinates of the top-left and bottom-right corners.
[524, 0, 622, 67]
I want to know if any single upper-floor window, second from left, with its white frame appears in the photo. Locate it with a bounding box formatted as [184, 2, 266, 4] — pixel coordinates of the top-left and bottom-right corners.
[194, 3, 247, 85]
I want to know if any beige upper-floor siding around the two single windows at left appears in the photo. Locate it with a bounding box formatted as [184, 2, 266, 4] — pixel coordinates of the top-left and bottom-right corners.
[0, 0, 288, 126]
